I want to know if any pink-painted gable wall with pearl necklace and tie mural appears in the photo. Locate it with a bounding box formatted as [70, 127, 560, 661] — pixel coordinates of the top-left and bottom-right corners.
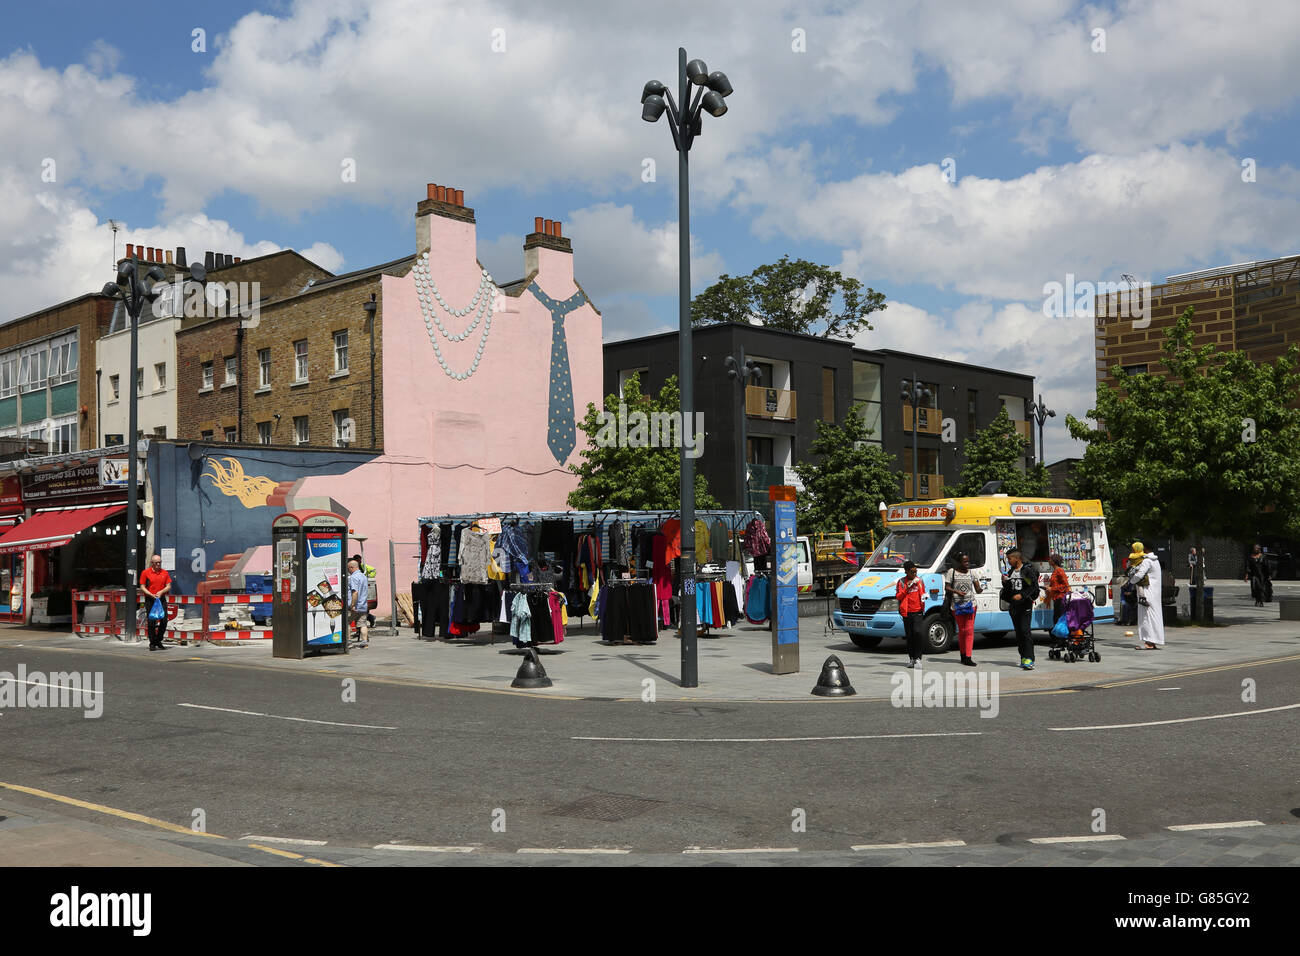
[300, 201, 603, 614]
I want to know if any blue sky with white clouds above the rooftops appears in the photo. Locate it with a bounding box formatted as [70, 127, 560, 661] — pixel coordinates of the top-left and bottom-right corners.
[0, 0, 1300, 462]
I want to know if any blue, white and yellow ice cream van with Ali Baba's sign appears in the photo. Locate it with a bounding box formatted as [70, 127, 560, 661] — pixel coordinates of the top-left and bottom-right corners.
[832, 494, 1114, 653]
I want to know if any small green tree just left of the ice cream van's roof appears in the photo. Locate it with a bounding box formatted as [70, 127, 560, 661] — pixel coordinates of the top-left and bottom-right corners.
[794, 405, 902, 540]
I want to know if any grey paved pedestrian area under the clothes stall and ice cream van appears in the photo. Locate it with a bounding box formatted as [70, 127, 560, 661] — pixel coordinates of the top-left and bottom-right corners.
[0, 574, 1300, 701]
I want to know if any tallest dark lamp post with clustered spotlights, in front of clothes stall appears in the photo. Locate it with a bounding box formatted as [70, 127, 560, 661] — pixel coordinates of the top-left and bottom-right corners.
[641, 47, 732, 687]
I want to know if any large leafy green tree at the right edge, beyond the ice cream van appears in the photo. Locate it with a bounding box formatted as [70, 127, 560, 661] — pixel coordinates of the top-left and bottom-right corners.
[1066, 306, 1300, 542]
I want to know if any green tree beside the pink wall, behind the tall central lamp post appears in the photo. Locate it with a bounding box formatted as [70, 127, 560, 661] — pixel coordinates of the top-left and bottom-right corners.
[568, 375, 722, 511]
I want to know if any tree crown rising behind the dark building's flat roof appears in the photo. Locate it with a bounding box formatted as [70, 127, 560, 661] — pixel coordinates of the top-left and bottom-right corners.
[690, 256, 885, 338]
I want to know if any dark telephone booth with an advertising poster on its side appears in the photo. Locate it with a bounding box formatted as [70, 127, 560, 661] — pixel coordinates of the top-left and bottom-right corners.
[270, 511, 351, 661]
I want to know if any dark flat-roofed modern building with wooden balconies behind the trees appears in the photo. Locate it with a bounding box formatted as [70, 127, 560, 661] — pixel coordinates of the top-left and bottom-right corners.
[605, 324, 1034, 510]
